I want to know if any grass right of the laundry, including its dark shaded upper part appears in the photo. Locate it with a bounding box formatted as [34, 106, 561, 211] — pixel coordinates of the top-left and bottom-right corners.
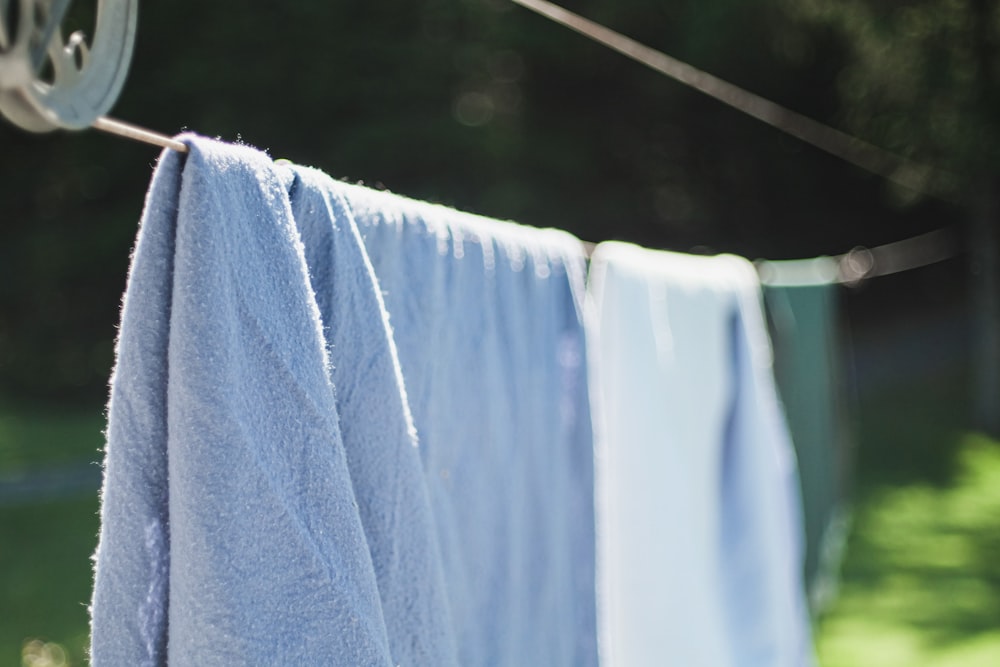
[816, 370, 1000, 667]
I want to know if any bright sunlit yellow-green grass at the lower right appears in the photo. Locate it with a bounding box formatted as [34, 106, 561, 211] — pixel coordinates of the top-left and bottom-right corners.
[817, 435, 1000, 667]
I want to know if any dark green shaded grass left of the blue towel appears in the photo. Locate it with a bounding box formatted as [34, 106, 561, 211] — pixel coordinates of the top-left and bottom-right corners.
[0, 403, 104, 667]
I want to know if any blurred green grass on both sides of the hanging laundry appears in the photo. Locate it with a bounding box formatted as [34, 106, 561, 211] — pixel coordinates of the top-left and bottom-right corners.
[0, 374, 1000, 667]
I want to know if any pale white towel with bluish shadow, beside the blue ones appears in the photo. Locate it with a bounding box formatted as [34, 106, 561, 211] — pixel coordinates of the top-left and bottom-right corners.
[588, 242, 812, 667]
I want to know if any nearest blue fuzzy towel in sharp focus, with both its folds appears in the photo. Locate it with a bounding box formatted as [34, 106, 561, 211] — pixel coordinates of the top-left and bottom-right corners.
[91, 137, 457, 667]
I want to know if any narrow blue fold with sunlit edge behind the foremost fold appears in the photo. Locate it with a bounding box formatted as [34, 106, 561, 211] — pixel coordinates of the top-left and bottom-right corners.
[292, 167, 457, 666]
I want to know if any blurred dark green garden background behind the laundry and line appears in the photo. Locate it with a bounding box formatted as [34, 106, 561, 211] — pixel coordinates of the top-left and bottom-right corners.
[0, 0, 1000, 667]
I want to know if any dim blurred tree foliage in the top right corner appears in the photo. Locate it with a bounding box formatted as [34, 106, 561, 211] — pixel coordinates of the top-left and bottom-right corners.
[788, 0, 1000, 185]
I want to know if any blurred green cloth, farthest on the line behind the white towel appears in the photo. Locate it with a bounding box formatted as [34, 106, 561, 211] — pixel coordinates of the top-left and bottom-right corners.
[759, 257, 853, 617]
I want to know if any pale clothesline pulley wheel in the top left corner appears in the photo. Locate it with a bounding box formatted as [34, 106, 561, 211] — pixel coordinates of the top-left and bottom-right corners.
[0, 0, 138, 132]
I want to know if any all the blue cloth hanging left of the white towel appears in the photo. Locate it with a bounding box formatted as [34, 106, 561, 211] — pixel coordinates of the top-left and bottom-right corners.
[92, 137, 596, 667]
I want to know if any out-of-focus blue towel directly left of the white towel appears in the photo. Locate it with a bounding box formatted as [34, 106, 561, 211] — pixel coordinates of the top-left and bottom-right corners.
[337, 184, 597, 667]
